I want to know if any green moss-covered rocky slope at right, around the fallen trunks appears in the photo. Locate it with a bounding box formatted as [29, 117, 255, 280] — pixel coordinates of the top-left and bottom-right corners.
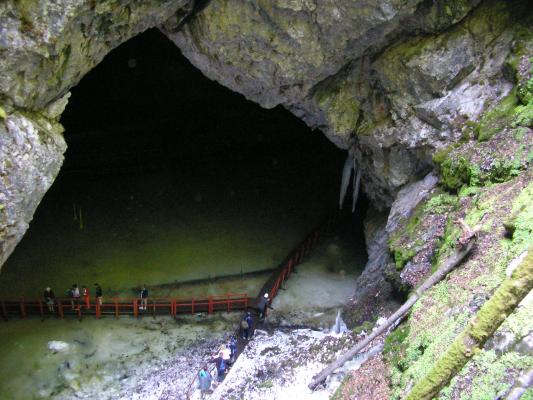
[387, 170, 533, 400]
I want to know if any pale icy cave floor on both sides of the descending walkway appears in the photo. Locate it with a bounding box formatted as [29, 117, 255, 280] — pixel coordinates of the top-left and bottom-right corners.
[0, 239, 366, 400]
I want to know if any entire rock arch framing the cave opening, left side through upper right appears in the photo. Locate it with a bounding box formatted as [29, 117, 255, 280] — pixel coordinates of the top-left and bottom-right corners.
[0, 0, 528, 268]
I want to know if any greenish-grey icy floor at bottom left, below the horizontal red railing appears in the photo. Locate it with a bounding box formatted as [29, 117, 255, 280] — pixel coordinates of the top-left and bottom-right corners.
[0, 314, 239, 400]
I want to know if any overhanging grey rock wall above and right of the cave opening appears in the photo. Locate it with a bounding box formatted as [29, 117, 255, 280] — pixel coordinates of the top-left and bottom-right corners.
[166, 0, 527, 207]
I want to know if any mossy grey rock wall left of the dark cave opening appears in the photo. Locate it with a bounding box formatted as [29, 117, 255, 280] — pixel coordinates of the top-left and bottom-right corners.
[0, 0, 192, 266]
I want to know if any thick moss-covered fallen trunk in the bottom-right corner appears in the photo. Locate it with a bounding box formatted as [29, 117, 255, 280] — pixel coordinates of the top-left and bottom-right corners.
[406, 246, 533, 400]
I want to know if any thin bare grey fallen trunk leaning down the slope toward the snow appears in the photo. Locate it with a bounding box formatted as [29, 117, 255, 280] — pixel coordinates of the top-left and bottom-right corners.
[308, 236, 476, 390]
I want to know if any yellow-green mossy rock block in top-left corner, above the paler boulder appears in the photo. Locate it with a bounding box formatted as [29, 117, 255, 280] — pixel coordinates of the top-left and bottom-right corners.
[0, 0, 190, 110]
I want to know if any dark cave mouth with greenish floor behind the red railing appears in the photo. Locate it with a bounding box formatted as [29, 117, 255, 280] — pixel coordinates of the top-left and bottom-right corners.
[0, 29, 366, 297]
